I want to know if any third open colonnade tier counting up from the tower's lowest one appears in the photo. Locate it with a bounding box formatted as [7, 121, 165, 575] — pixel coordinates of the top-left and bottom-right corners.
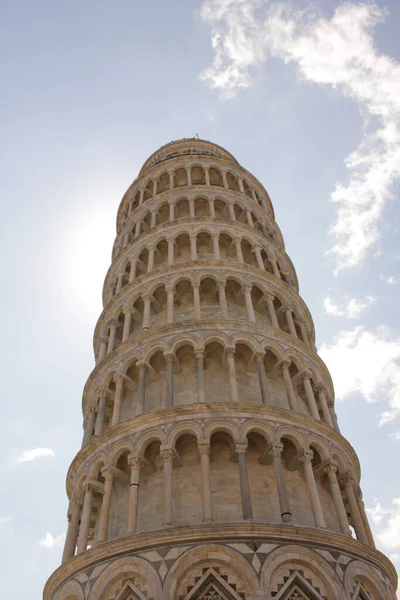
[93, 262, 315, 362]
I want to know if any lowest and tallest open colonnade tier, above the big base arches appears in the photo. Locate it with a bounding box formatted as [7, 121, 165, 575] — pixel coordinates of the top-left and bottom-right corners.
[66, 404, 373, 558]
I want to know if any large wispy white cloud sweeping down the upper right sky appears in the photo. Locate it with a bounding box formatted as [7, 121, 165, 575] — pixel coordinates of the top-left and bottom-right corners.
[200, 0, 400, 273]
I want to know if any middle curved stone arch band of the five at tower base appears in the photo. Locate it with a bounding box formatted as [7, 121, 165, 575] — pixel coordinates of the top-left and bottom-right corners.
[162, 545, 260, 600]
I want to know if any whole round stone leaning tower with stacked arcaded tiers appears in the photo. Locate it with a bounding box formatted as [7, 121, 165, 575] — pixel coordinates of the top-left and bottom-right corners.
[44, 139, 396, 600]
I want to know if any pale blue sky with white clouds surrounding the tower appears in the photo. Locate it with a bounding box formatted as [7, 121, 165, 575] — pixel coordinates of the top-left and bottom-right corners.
[0, 0, 400, 600]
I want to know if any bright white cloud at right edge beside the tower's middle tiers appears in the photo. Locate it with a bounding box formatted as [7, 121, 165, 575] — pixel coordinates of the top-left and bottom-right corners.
[319, 326, 400, 425]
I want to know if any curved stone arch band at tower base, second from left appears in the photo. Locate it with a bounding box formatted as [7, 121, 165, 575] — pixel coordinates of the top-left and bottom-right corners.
[88, 557, 162, 600]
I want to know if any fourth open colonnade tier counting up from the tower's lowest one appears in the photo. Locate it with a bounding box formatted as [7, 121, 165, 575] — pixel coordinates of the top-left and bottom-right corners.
[103, 223, 298, 305]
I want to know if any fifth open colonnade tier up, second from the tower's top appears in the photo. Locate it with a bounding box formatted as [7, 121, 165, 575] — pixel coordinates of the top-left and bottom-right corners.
[113, 190, 284, 258]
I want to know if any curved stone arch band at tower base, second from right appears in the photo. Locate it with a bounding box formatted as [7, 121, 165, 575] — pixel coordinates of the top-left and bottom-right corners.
[260, 545, 346, 600]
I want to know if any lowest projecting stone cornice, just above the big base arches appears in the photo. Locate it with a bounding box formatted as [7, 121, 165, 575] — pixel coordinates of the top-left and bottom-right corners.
[43, 523, 397, 600]
